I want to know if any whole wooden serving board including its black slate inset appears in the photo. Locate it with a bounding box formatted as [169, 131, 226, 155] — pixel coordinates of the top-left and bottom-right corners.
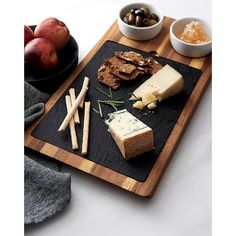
[25, 17, 211, 197]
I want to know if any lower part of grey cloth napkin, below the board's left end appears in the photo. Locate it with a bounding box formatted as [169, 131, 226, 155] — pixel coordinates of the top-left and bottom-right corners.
[24, 156, 71, 224]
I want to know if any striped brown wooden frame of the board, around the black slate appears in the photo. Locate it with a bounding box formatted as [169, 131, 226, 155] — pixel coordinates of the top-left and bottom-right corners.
[25, 17, 211, 197]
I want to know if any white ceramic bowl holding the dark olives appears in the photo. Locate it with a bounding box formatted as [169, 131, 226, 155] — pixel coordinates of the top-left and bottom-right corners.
[118, 3, 163, 41]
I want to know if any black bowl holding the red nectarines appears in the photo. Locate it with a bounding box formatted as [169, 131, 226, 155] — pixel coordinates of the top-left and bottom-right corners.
[25, 26, 79, 93]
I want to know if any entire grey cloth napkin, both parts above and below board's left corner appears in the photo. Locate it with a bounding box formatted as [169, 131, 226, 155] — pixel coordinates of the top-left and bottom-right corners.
[24, 82, 71, 224]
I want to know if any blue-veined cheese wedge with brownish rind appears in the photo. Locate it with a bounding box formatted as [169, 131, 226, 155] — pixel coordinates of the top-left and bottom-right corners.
[107, 109, 153, 160]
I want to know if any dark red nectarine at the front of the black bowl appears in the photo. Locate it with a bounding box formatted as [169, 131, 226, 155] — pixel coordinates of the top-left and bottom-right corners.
[25, 38, 58, 70]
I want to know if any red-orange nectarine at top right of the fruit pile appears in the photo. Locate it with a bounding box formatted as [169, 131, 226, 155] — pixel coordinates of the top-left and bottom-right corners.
[34, 17, 70, 50]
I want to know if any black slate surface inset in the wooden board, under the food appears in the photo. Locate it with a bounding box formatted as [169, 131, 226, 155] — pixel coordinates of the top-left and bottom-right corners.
[32, 41, 202, 181]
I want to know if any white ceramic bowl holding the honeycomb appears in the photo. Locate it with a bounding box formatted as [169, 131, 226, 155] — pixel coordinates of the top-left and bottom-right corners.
[170, 17, 212, 57]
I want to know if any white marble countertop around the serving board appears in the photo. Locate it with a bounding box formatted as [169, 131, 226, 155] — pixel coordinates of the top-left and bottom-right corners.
[24, 0, 212, 236]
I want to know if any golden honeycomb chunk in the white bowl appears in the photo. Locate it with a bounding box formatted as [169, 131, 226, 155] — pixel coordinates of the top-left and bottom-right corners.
[179, 21, 211, 44]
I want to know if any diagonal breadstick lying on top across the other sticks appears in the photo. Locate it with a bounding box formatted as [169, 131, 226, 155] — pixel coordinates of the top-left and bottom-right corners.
[58, 82, 88, 131]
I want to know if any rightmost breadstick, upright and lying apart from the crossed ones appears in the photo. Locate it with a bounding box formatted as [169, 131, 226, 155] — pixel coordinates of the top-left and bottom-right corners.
[82, 102, 90, 155]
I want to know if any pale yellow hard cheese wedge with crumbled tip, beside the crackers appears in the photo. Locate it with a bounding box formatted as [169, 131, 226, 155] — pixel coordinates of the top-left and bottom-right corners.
[130, 65, 184, 109]
